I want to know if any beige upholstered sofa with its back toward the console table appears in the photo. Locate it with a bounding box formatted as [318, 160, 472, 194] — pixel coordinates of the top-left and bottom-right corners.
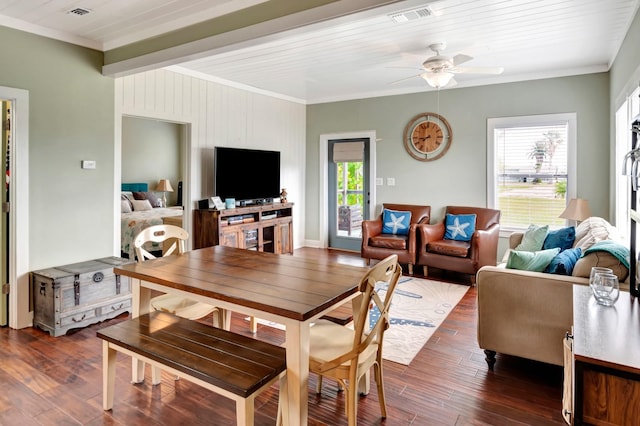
[476, 218, 628, 369]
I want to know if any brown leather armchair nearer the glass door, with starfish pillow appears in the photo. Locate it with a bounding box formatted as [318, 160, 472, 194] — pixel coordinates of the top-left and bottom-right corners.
[360, 204, 431, 274]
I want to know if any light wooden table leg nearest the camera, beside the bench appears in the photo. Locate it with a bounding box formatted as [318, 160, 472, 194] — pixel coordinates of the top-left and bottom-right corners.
[285, 322, 309, 426]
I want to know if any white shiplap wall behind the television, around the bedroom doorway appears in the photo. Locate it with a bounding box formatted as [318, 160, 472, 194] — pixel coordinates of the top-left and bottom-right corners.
[114, 70, 306, 247]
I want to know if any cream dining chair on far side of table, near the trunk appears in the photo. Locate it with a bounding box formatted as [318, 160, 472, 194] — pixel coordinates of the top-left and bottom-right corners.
[133, 225, 230, 329]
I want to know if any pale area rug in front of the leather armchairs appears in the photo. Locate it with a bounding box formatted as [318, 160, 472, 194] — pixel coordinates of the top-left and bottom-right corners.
[246, 277, 469, 365]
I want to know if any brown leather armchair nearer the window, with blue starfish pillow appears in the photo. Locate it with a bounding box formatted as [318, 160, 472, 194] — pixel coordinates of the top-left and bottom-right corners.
[417, 206, 500, 283]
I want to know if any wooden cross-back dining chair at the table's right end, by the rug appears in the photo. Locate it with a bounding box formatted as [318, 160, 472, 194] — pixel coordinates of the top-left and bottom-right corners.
[278, 254, 402, 426]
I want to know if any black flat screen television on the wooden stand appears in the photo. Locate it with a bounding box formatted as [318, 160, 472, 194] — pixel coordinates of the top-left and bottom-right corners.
[214, 146, 280, 206]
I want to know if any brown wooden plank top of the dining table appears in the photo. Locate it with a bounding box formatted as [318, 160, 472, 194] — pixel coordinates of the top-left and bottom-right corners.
[114, 246, 368, 321]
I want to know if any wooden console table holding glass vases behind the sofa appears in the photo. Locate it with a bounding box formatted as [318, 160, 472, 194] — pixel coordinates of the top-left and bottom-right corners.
[573, 284, 640, 425]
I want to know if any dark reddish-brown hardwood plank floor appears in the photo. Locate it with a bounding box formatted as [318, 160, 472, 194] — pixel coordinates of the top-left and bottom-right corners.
[0, 248, 564, 426]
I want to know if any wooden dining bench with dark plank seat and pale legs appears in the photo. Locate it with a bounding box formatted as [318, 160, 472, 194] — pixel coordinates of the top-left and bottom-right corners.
[97, 311, 286, 425]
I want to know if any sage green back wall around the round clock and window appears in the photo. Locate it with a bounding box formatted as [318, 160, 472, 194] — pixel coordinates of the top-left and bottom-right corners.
[306, 73, 609, 240]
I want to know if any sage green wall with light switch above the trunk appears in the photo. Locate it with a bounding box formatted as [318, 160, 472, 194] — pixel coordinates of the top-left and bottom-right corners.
[0, 27, 115, 270]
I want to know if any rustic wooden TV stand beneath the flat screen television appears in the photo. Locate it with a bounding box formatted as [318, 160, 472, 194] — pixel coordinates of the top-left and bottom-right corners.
[193, 203, 293, 254]
